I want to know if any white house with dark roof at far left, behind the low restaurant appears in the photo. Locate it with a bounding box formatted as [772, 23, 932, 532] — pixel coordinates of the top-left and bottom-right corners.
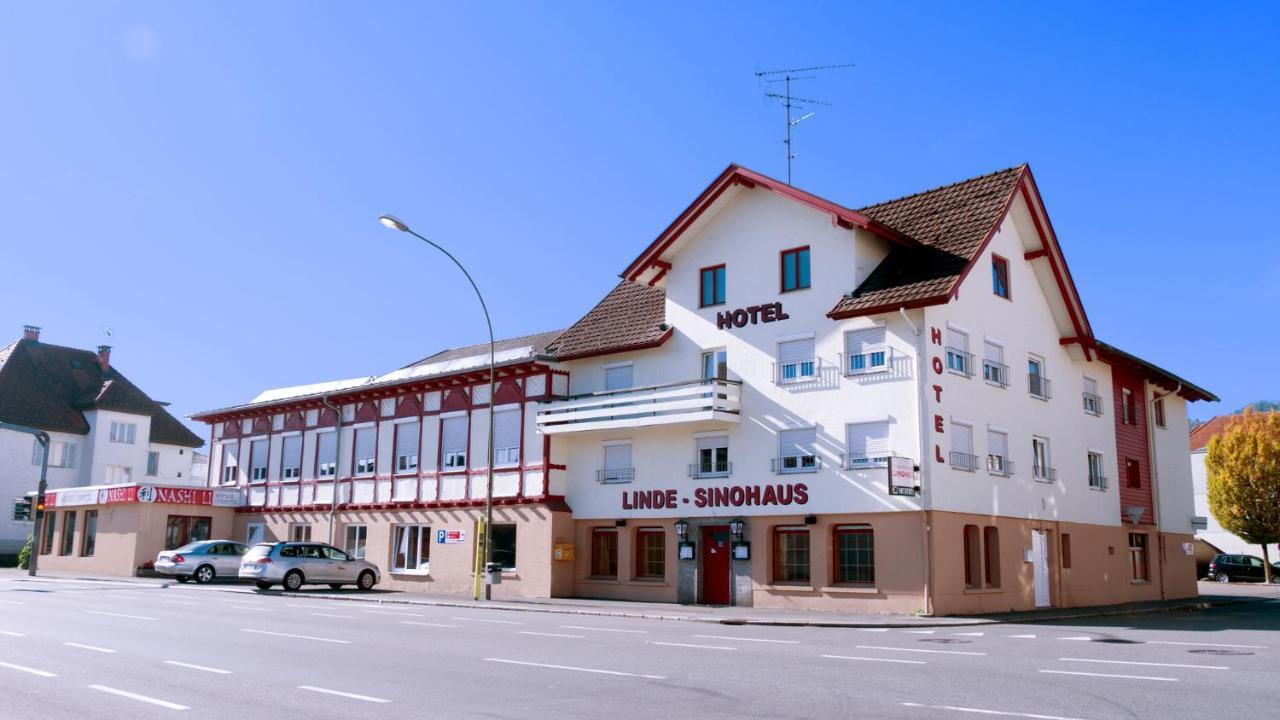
[0, 325, 204, 556]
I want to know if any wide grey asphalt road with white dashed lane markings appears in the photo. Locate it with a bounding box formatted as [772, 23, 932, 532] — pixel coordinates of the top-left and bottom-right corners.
[0, 579, 1280, 720]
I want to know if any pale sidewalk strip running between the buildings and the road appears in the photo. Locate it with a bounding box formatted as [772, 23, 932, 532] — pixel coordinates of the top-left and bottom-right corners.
[0, 569, 1280, 628]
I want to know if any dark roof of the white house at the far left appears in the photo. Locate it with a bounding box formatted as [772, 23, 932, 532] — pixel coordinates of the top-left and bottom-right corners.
[0, 340, 205, 447]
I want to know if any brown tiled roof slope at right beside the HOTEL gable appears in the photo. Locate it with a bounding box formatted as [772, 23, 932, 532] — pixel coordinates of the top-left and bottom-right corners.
[829, 165, 1027, 316]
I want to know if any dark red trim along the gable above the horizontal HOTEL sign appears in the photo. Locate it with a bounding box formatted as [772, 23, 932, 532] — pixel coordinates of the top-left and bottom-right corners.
[622, 165, 919, 282]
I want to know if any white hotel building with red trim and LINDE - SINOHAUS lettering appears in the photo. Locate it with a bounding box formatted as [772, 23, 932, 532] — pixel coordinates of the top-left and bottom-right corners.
[197, 165, 1213, 614]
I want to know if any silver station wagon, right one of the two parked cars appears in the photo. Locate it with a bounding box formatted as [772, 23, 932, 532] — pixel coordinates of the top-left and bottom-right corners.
[239, 542, 381, 591]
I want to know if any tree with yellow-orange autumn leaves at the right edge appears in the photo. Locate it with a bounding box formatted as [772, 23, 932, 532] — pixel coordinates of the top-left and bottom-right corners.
[1204, 410, 1280, 583]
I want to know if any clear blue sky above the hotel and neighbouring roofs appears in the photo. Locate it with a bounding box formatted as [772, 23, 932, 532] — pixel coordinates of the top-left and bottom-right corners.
[0, 1, 1280, 434]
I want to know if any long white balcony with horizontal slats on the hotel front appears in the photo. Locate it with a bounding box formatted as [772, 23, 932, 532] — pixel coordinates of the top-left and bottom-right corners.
[538, 379, 742, 434]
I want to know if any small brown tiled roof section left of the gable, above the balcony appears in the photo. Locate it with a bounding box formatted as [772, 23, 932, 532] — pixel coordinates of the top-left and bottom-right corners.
[547, 281, 671, 360]
